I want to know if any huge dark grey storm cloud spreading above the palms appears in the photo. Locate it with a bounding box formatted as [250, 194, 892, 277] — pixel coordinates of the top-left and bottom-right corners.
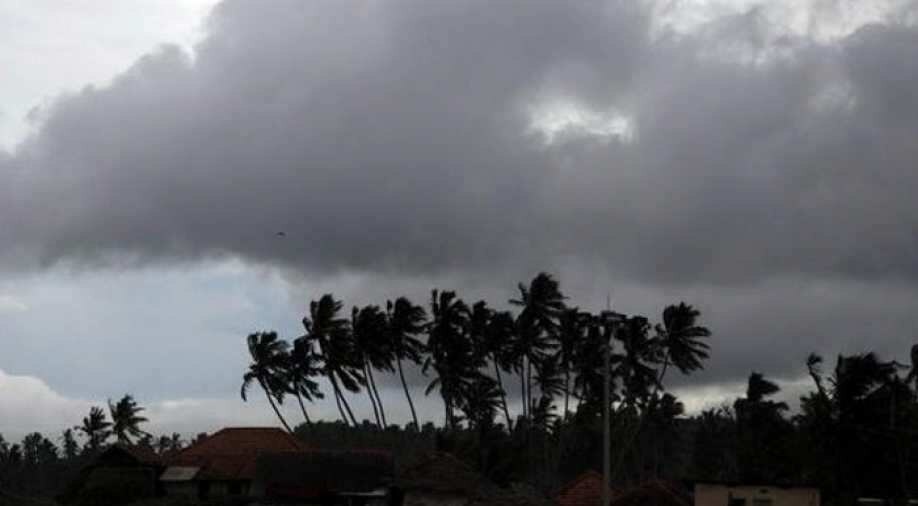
[0, 1, 918, 392]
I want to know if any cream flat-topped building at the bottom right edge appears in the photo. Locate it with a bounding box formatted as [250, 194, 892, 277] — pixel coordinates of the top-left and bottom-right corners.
[695, 483, 820, 506]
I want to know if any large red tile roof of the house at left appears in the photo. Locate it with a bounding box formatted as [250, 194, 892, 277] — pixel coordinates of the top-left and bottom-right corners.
[169, 427, 306, 480]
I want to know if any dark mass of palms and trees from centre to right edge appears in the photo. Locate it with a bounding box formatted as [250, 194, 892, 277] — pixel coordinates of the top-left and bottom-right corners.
[242, 273, 918, 504]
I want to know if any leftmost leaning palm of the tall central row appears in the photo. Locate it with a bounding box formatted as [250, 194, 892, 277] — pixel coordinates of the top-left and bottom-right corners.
[239, 332, 293, 432]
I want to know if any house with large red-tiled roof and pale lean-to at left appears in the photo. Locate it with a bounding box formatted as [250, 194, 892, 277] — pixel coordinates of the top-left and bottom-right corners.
[159, 427, 306, 500]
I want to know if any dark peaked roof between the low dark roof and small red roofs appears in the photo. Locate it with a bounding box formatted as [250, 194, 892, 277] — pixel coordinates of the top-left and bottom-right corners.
[398, 452, 487, 496]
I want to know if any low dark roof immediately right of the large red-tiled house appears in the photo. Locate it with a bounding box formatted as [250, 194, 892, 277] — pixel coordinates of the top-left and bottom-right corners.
[255, 450, 395, 497]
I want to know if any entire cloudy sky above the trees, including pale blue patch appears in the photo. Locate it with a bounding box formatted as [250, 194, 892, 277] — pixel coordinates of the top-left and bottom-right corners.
[0, 0, 918, 437]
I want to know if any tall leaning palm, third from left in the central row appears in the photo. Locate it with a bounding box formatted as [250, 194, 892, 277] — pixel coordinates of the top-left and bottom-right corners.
[303, 294, 366, 427]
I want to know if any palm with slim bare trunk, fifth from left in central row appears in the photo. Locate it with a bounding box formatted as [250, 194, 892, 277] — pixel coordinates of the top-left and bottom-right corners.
[386, 297, 427, 430]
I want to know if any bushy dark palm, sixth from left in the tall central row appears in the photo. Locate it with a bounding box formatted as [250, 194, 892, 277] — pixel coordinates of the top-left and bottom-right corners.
[423, 290, 474, 428]
